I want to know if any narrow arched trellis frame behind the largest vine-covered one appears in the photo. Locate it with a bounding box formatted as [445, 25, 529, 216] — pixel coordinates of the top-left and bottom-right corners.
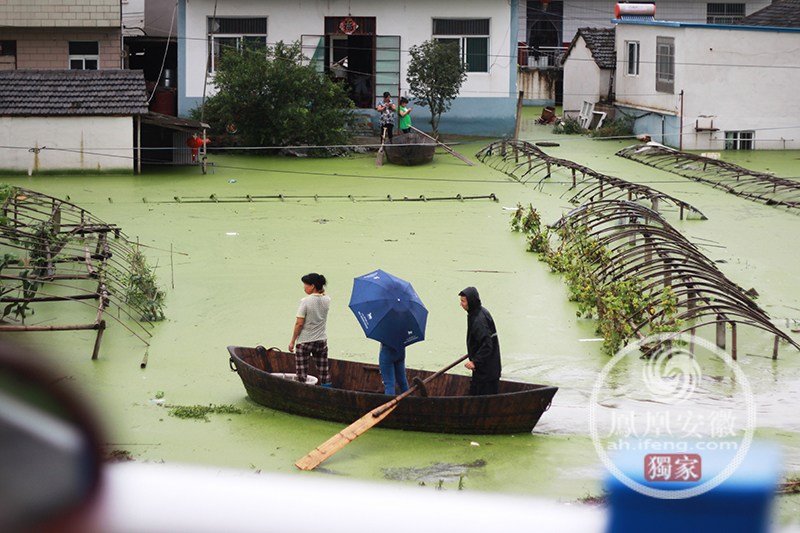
[477, 141, 706, 220]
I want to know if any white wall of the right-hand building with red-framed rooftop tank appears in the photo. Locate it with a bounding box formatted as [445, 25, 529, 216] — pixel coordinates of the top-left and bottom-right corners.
[615, 23, 800, 151]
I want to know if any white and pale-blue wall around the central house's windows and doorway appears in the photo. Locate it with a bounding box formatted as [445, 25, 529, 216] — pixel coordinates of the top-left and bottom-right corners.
[178, 0, 519, 136]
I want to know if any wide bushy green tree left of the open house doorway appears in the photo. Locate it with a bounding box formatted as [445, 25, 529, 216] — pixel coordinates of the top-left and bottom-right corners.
[193, 41, 355, 152]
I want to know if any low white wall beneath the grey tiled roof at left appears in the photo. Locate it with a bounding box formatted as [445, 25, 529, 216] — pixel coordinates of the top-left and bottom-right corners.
[0, 117, 134, 174]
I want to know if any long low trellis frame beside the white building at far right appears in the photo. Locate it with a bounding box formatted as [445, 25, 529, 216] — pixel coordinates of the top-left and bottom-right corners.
[617, 143, 800, 214]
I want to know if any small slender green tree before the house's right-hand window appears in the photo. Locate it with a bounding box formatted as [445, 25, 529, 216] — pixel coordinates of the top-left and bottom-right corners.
[406, 40, 467, 137]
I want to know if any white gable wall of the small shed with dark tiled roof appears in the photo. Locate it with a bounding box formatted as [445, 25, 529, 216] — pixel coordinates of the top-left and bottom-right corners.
[563, 38, 612, 118]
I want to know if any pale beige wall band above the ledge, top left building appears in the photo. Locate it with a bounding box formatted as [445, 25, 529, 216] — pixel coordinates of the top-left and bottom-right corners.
[0, 0, 121, 28]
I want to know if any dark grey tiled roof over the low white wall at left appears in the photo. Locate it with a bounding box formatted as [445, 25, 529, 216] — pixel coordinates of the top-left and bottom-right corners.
[0, 70, 148, 116]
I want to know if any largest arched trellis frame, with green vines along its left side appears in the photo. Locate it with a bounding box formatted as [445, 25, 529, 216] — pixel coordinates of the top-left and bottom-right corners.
[551, 200, 800, 359]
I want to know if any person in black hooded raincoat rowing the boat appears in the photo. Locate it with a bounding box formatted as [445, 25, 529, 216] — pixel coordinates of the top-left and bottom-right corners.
[458, 287, 501, 396]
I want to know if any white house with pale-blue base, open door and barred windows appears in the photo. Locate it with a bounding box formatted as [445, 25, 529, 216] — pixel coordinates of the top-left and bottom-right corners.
[178, 0, 519, 137]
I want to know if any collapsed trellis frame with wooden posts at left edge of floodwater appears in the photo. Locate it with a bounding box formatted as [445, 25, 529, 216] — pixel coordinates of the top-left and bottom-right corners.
[0, 187, 158, 359]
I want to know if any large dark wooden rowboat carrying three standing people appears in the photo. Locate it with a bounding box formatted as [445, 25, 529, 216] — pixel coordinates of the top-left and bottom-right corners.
[228, 346, 558, 435]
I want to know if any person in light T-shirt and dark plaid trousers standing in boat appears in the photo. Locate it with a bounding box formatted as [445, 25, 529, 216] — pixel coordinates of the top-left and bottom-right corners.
[289, 273, 331, 387]
